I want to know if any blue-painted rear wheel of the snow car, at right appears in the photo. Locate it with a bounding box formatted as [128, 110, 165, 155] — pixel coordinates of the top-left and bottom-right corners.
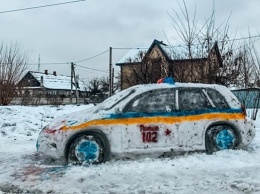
[206, 125, 238, 154]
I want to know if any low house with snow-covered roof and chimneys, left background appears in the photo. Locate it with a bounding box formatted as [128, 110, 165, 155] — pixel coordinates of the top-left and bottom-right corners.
[18, 70, 88, 104]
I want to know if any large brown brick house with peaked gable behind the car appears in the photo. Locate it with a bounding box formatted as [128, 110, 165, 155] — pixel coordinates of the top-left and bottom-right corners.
[116, 40, 223, 89]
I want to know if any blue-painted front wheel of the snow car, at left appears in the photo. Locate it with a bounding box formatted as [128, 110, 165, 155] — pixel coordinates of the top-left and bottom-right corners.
[67, 132, 110, 164]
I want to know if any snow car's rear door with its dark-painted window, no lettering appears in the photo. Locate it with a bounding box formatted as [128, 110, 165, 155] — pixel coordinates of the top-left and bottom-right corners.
[177, 88, 215, 150]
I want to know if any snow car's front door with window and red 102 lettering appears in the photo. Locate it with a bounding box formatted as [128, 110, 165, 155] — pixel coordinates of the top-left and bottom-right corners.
[123, 88, 178, 152]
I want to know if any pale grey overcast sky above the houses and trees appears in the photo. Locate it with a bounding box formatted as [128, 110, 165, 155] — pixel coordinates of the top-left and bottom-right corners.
[0, 0, 260, 81]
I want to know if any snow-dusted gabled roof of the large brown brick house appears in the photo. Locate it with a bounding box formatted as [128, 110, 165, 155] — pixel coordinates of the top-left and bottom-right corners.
[116, 39, 222, 66]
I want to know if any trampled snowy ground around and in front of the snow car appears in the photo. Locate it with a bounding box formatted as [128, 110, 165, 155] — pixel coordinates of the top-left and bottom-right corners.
[0, 105, 260, 194]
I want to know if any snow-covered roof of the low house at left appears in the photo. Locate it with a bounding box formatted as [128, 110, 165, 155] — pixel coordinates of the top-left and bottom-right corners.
[28, 71, 87, 91]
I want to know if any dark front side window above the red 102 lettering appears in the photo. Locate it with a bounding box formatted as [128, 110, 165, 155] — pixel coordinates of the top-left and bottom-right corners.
[124, 88, 176, 113]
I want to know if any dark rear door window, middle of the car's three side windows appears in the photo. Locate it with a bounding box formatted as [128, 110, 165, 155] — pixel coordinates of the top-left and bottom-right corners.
[178, 88, 212, 110]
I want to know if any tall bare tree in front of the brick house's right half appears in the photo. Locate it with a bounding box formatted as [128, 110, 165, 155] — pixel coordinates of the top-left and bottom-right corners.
[168, 0, 238, 84]
